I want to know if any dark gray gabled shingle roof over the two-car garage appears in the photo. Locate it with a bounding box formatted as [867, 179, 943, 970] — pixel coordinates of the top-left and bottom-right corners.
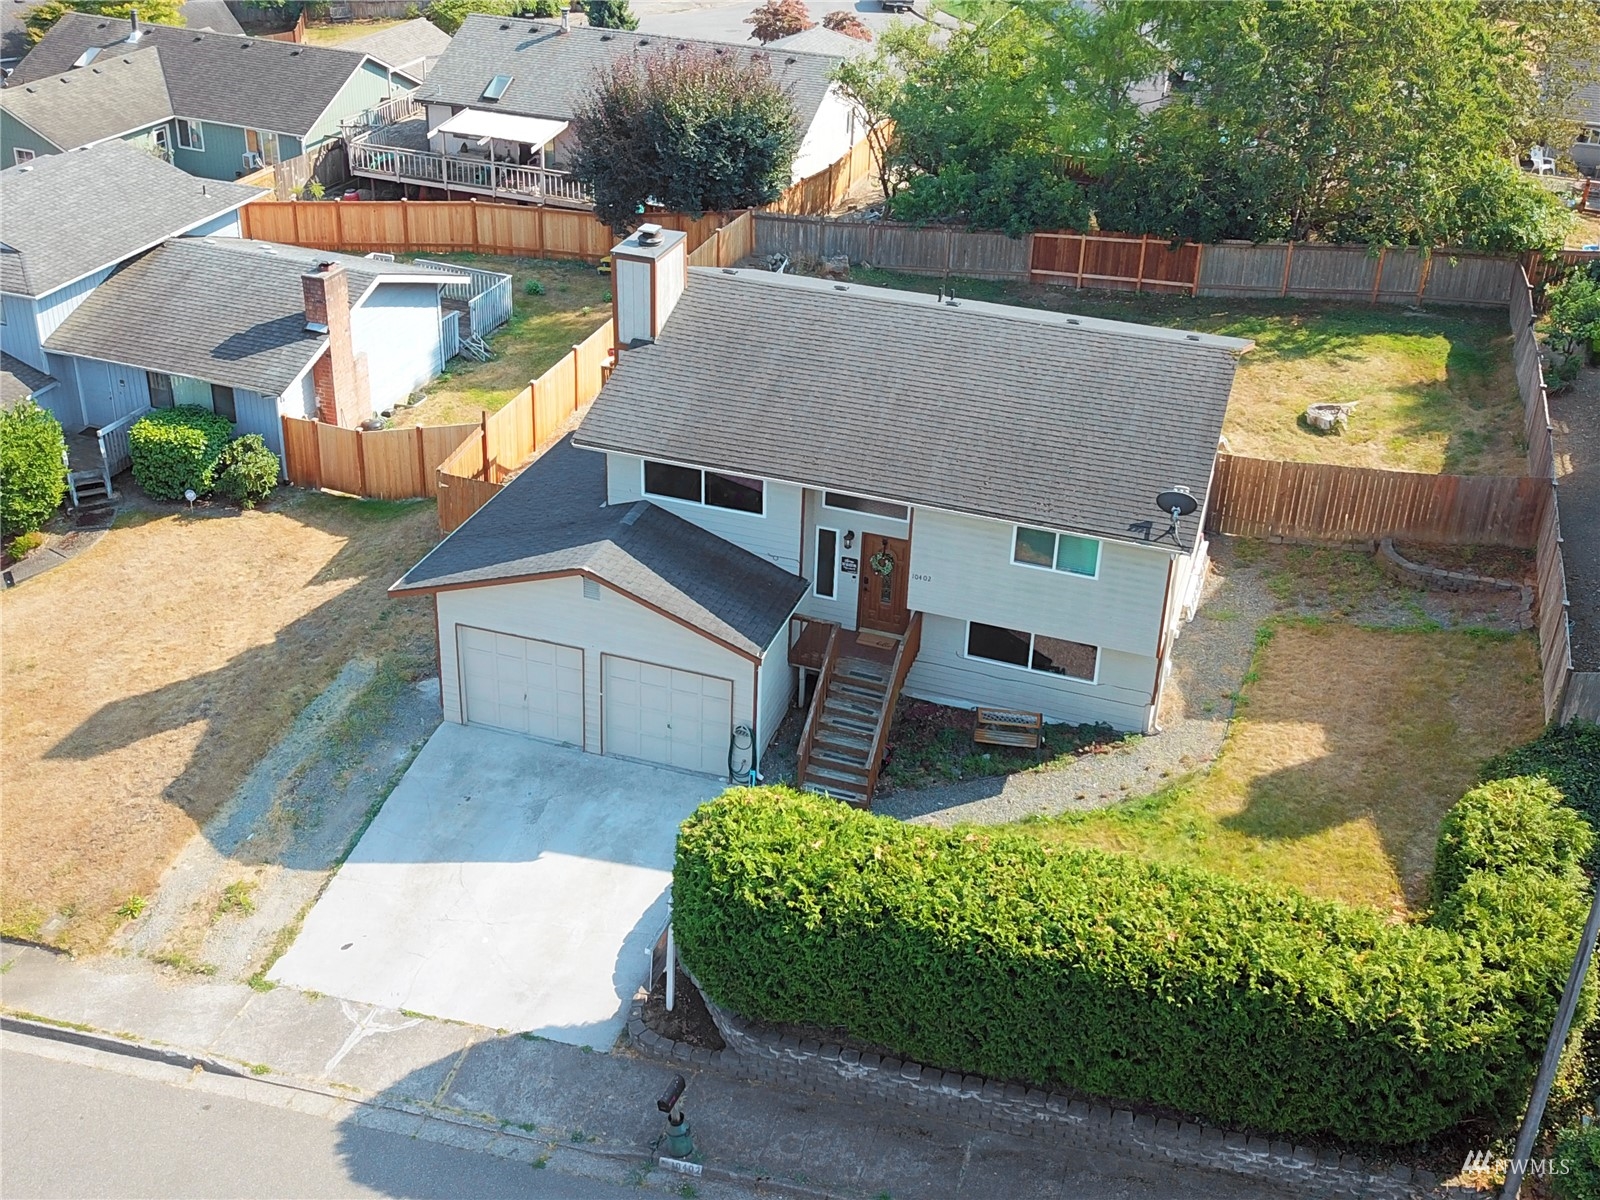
[390, 437, 806, 654]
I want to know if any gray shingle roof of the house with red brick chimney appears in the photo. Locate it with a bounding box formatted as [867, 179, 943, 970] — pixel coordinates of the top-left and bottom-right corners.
[45, 237, 451, 395]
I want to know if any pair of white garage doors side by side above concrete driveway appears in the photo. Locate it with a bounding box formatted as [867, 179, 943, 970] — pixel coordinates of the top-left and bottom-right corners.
[458, 626, 733, 774]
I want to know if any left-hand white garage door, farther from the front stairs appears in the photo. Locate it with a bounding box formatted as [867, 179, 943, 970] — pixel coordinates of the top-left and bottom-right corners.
[456, 626, 584, 746]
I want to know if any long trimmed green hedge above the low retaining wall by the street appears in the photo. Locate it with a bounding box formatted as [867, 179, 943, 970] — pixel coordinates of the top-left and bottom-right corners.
[674, 782, 1589, 1144]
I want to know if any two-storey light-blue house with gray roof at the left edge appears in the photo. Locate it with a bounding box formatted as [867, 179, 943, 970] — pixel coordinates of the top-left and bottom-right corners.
[0, 141, 270, 432]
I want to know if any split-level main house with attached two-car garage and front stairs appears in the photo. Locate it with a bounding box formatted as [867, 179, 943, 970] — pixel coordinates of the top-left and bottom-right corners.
[392, 227, 1250, 802]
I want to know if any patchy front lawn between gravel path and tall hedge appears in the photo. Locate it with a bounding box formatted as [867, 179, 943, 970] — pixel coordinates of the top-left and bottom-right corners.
[1021, 621, 1544, 917]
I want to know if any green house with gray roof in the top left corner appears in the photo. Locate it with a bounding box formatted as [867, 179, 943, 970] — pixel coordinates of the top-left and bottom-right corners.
[0, 13, 418, 179]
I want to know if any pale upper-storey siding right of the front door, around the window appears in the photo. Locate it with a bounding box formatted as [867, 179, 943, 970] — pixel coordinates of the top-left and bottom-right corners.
[909, 509, 1171, 659]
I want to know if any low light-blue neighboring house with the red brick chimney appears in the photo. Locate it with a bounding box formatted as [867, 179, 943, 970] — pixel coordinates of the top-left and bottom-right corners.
[45, 237, 469, 458]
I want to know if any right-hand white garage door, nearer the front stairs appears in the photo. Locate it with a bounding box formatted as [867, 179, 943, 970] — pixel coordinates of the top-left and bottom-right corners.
[602, 654, 733, 774]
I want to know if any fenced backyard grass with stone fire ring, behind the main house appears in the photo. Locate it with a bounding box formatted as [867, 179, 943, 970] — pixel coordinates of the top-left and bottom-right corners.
[851, 267, 1526, 475]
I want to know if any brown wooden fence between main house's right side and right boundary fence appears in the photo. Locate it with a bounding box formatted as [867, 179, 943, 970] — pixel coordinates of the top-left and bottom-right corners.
[1206, 454, 1549, 547]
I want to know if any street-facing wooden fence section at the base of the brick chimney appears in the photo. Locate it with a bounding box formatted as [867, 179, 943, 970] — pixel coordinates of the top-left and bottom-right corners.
[283, 416, 478, 499]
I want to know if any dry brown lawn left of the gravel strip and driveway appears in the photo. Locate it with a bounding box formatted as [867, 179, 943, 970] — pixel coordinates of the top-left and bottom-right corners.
[0, 493, 437, 950]
